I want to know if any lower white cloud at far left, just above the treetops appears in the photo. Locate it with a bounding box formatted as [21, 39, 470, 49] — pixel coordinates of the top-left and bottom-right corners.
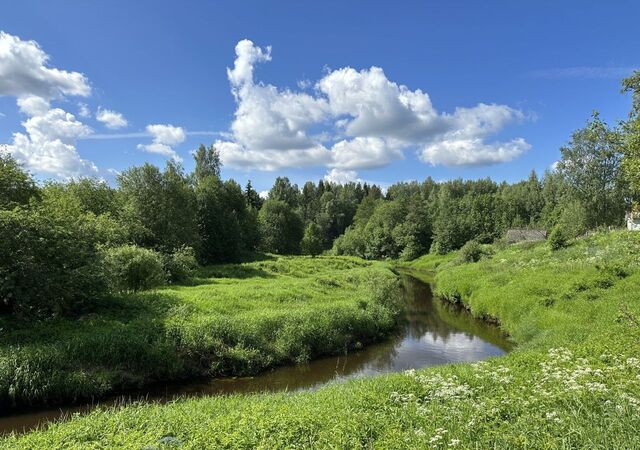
[0, 108, 97, 178]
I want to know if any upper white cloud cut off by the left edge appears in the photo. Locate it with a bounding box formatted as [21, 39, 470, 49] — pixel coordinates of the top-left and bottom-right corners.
[0, 32, 91, 99]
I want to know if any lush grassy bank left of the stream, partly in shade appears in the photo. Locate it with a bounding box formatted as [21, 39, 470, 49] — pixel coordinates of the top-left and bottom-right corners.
[0, 257, 398, 408]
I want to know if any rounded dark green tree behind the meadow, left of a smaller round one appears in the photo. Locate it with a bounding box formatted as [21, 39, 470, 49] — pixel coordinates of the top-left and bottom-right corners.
[258, 199, 304, 255]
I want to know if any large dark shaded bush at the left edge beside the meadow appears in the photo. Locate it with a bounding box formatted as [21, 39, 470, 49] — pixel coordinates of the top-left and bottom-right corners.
[0, 208, 106, 315]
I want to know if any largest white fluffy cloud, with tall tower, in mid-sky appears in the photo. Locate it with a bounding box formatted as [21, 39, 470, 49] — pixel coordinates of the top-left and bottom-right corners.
[217, 40, 530, 172]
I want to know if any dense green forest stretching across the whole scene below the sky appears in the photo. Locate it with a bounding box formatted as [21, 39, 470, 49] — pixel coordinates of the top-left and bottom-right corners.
[0, 72, 640, 316]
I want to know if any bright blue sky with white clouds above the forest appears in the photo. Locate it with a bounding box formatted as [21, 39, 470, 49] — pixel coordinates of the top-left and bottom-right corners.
[0, 0, 640, 190]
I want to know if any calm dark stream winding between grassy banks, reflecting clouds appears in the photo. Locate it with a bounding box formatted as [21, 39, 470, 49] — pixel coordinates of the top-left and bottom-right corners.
[0, 274, 511, 433]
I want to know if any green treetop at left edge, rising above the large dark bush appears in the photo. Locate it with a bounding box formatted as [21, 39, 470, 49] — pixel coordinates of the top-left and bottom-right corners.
[0, 152, 38, 209]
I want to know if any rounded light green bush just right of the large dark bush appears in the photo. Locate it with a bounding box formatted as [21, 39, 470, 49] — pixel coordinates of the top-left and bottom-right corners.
[104, 245, 165, 292]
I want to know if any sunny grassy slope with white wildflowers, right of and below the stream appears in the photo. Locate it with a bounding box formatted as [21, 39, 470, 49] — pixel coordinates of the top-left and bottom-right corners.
[3, 233, 640, 449]
